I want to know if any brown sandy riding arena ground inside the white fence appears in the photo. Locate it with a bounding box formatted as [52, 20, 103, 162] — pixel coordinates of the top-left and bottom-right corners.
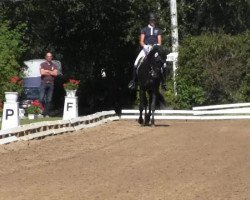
[0, 120, 250, 200]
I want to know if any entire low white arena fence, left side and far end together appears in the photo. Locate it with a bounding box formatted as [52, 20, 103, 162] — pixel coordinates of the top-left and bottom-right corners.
[0, 103, 250, 144]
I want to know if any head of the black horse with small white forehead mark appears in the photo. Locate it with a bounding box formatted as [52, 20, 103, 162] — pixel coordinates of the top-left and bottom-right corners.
[147, 45, 167, 79]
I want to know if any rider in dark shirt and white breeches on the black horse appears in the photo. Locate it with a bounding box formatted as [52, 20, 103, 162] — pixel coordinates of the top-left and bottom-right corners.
[128, 13, 166, 90]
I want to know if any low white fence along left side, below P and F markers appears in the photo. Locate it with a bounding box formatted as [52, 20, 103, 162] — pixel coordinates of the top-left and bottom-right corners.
[0, 110, 119, 144]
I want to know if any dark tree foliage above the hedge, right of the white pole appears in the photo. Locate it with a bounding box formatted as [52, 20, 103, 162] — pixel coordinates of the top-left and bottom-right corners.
[178, 0, 250, 38]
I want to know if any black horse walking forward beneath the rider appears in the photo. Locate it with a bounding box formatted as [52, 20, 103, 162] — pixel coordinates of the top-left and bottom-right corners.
[137, 45, 167, 125]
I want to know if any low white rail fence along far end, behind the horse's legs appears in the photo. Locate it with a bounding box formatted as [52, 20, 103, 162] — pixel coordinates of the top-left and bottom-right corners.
[121, 103, 250, 120]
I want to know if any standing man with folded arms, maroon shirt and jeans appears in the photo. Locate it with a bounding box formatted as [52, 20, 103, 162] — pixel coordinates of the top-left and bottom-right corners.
[40, 52, 58, 116]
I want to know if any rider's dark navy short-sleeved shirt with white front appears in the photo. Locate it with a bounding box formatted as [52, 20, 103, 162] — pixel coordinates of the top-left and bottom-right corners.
[141, 25, 162, 45]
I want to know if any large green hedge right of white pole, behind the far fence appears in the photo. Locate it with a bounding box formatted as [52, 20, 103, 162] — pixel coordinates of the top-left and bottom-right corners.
[175, 32, 250, 108]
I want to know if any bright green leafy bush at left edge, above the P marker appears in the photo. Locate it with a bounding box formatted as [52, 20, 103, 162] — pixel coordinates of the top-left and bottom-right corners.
[0, 21, 26, 99]
